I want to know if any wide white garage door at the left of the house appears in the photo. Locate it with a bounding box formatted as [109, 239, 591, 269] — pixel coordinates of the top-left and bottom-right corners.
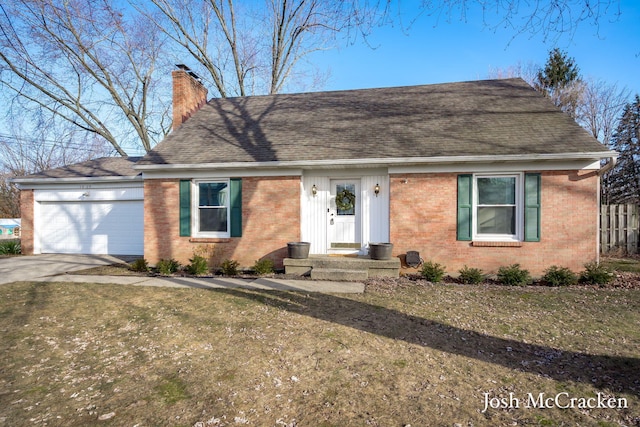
[40, 200, 144, 255]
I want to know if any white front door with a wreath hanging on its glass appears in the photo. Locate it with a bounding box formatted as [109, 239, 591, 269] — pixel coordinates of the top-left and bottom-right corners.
[327, 179, 362, 253]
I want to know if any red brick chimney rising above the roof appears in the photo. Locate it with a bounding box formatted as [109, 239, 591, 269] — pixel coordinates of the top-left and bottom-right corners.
[171, 64, 207, 130]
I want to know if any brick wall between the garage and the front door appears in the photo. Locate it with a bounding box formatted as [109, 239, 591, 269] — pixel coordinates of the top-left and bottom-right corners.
[144, 177, 300, 267]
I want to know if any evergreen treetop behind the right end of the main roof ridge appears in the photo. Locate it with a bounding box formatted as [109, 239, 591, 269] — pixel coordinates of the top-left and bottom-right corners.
[534, 48, 582, 118]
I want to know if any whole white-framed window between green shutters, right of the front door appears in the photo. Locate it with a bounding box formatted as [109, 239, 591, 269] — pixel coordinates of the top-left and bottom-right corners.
[472, 173, 524, 241]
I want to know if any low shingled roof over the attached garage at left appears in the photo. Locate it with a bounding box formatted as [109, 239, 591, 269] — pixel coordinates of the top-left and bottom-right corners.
[13, 157, 142, 184]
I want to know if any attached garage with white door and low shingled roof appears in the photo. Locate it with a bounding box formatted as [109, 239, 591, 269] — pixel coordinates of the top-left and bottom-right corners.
[15, 157, 144, 255]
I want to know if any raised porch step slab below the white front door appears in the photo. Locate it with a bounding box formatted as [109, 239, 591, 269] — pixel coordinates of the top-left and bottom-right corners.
[284, 255, 400, 280]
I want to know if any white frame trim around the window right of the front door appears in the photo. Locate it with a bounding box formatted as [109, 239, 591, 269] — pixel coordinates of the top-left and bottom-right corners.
[471, 173, 524, 242]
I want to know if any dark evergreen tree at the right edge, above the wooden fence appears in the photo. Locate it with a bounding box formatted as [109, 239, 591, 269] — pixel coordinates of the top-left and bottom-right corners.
[605, 95, 640, 203]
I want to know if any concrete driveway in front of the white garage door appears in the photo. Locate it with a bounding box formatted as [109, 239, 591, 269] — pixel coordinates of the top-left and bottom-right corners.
[0, 254, 128, 284]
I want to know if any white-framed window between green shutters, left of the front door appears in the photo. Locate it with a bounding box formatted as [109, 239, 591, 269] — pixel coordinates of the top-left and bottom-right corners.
[192, 179, 231, 238]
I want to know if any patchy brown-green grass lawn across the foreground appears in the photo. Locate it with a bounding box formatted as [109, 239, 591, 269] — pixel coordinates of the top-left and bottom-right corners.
[0, 282, 640, 427]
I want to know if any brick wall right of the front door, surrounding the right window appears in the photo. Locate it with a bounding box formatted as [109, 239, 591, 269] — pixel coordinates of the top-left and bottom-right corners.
[390, 171, 599, 276]
